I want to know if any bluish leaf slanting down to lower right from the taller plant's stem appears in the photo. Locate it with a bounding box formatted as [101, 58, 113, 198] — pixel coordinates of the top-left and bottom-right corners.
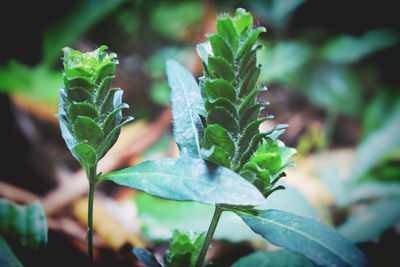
[236, 210, 366, 266]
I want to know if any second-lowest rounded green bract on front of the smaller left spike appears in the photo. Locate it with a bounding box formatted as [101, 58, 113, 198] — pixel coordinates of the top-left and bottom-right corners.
[74, 116, 104, 148]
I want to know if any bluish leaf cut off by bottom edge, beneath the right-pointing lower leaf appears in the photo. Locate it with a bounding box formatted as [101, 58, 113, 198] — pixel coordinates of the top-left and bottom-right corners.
[232, 249, 315, 267]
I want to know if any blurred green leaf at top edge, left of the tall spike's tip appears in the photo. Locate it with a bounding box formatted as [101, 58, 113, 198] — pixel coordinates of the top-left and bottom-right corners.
[150, 1, 203, 41]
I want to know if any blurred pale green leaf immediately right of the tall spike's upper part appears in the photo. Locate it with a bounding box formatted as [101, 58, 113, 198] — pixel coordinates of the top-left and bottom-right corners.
[258, 41, 312, 84]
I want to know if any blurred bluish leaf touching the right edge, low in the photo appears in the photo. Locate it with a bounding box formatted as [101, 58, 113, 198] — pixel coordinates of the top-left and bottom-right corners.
[338, 197, 400, 243]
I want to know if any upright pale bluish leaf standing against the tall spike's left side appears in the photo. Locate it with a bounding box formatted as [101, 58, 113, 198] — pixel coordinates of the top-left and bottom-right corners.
[167, 60, 205, 158]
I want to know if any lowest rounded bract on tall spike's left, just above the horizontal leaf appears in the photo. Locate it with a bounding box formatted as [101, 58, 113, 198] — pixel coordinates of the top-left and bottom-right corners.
[204, 124, 235, 157]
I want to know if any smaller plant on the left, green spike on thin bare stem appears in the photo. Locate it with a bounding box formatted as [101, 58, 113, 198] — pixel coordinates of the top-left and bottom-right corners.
[57, 46, 133, 260]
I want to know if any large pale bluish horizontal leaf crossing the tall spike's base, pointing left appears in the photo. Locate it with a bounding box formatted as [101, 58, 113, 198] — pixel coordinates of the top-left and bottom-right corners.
[100, 158, 264, 206]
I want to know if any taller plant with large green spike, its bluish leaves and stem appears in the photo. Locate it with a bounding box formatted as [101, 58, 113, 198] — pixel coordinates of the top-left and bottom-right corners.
[101, 9, 366, 266]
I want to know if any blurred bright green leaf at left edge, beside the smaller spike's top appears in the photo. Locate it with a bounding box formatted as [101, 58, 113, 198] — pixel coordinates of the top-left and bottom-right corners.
[0, 61, 62, 104]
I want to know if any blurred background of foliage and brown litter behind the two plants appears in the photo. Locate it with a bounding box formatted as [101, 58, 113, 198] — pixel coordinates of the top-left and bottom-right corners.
[0, 0, 400, 266]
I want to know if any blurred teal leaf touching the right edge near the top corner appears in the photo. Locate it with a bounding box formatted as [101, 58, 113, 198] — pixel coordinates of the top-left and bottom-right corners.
[321, 29, 399, 64]
